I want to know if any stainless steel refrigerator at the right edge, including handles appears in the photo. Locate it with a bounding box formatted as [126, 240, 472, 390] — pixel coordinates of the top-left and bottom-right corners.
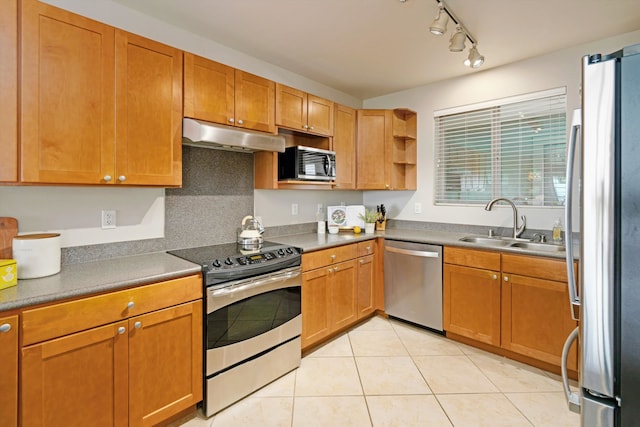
[563, 45, 640, 427]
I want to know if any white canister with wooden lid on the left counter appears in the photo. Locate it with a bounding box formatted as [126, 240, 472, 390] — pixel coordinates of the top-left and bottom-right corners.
[13, 233, 60, 279]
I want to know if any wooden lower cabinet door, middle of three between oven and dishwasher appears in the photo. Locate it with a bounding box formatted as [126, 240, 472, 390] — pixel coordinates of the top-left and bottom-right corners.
[329, 260, 358, 331]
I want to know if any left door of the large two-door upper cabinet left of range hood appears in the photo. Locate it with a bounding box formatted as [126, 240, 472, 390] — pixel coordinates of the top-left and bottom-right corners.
[20, 0, 115, 184]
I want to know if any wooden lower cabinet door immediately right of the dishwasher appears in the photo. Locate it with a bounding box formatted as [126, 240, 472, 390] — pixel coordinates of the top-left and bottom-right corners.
[443, 264, 500, 346]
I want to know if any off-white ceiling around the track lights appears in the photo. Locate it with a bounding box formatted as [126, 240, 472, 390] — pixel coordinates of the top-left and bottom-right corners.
[114, 0, 640, 99]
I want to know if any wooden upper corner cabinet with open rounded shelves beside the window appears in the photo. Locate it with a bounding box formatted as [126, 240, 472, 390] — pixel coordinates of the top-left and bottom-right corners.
[356, 108, 417, 190]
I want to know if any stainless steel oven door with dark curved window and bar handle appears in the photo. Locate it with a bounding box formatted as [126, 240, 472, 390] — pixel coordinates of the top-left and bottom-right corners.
[205, 266, 302, 376]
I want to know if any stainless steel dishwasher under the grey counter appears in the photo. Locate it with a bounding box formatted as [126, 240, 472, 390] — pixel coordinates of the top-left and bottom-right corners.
[384, 239, 442, 332]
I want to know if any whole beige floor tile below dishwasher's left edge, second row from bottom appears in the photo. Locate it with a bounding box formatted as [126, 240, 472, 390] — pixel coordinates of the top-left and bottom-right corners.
[356, 356, 431, 395]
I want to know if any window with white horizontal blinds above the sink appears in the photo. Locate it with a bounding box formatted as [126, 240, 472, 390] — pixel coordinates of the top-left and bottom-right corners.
[435, 88, 566, 206]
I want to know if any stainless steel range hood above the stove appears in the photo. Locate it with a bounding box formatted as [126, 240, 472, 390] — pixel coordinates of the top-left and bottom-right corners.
[182, 118, 285, 153]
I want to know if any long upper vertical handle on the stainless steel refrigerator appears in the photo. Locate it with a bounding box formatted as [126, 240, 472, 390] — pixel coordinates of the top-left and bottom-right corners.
[564, 110, 581, 320]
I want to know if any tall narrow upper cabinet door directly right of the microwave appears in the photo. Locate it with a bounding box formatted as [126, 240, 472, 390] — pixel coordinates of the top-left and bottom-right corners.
[333, 104, 356, 190]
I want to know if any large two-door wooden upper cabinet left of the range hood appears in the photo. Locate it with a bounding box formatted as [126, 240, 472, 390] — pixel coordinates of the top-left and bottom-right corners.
[20, 0, 182, 186]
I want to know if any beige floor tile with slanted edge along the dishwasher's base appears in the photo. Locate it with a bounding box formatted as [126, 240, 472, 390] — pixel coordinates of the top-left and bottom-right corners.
[391, 322, 464, 356]
